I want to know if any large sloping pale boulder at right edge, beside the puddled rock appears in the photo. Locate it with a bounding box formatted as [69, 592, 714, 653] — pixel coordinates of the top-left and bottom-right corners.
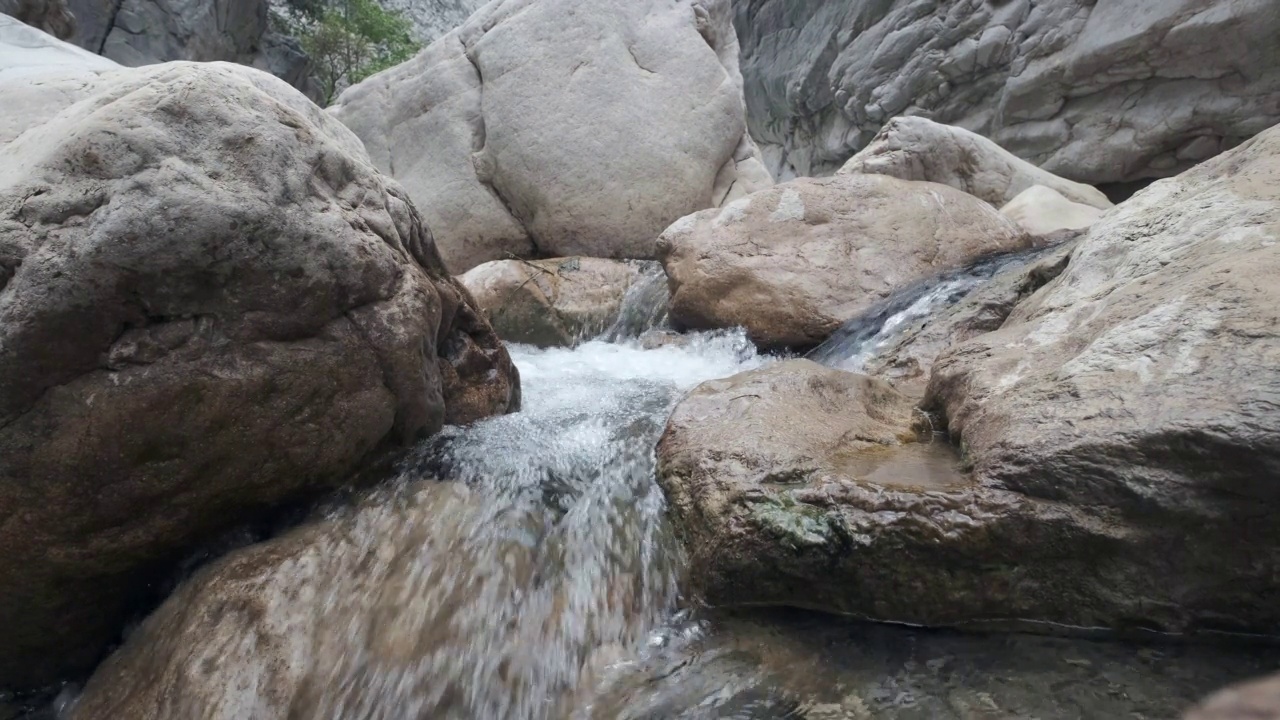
[925, 122, 1280, 633]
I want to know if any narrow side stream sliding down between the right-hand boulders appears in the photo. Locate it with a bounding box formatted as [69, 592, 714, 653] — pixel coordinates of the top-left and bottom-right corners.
[806, 249, 1052, 373]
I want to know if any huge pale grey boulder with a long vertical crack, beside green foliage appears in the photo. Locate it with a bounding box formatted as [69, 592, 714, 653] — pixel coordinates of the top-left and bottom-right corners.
[333, 0, 772, 273]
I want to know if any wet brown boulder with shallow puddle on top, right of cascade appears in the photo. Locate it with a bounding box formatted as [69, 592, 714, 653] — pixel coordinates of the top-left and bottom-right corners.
[657, 360, 1092, 624]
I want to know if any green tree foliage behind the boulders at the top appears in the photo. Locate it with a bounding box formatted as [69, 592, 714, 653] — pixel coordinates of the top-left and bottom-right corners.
[275, 0, 421, 105]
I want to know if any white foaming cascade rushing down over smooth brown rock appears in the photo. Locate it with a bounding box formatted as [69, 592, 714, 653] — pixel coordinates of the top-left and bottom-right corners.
[72, 332, 763, 720]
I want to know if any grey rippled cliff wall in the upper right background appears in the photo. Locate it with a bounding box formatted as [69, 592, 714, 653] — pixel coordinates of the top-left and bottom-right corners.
[735, 0, 1280, 184]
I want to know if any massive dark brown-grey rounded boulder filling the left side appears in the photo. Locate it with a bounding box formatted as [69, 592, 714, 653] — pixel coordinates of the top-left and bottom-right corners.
[0, 63, 518, 688]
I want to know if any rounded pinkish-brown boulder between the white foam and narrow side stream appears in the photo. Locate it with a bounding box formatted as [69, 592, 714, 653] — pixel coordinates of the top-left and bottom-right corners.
[659, 174, 1028, 348]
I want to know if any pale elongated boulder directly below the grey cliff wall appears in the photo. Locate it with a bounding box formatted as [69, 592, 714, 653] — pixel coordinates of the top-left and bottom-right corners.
[838, 118, 1111, 210]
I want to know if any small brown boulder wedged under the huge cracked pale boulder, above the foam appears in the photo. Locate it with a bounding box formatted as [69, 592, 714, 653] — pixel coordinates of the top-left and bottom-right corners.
[458, 258, 653, 347]
